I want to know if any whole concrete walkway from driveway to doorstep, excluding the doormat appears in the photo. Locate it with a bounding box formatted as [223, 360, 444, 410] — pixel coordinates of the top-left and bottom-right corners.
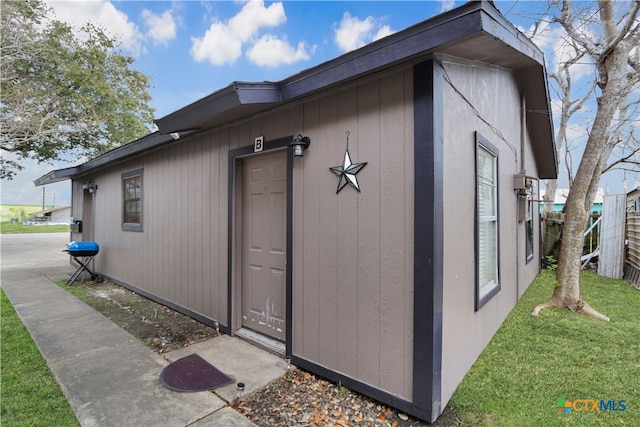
[0, 233, 287, 427]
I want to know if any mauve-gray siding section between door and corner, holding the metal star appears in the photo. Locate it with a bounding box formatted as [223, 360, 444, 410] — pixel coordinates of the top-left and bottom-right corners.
[293, 69, 413, 399]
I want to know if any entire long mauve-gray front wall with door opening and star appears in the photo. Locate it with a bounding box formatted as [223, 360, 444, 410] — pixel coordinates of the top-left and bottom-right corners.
[73, 68, 413, 399]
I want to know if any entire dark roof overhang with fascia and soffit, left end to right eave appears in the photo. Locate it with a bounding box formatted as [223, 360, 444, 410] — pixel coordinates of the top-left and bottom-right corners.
[34, 1, 557, 185]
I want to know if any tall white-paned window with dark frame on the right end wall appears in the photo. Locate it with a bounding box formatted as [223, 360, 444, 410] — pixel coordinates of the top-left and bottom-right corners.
[476, 134, 500, 310]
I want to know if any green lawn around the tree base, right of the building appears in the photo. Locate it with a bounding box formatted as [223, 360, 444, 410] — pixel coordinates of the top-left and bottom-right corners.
[449, 270, 640, 426]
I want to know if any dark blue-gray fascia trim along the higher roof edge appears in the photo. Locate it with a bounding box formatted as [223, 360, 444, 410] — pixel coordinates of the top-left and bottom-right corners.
[156, 1, 544, 133]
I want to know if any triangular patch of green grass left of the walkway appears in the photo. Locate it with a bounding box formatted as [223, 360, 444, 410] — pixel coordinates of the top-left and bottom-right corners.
[0, 290, 80, 427]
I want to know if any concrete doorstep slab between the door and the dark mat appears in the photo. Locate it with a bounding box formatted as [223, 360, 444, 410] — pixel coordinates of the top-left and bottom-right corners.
[165, 335, 288, 402]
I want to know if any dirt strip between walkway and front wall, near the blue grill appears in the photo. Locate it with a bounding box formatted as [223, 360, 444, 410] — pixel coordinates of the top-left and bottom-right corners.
[70, 281, 218, 354]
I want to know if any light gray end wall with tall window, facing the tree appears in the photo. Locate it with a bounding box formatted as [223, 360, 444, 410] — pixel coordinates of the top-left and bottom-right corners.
[442, 58, 539, 407]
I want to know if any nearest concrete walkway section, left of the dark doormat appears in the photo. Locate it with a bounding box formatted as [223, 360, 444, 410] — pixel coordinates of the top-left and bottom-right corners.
[50, 342, 225, 426]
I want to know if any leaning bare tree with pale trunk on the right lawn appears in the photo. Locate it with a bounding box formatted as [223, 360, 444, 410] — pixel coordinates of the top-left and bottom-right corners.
[531, 0, 640, 321]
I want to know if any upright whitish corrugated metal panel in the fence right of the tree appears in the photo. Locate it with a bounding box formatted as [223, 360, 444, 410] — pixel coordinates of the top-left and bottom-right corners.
[598, 194, 627, 279]
